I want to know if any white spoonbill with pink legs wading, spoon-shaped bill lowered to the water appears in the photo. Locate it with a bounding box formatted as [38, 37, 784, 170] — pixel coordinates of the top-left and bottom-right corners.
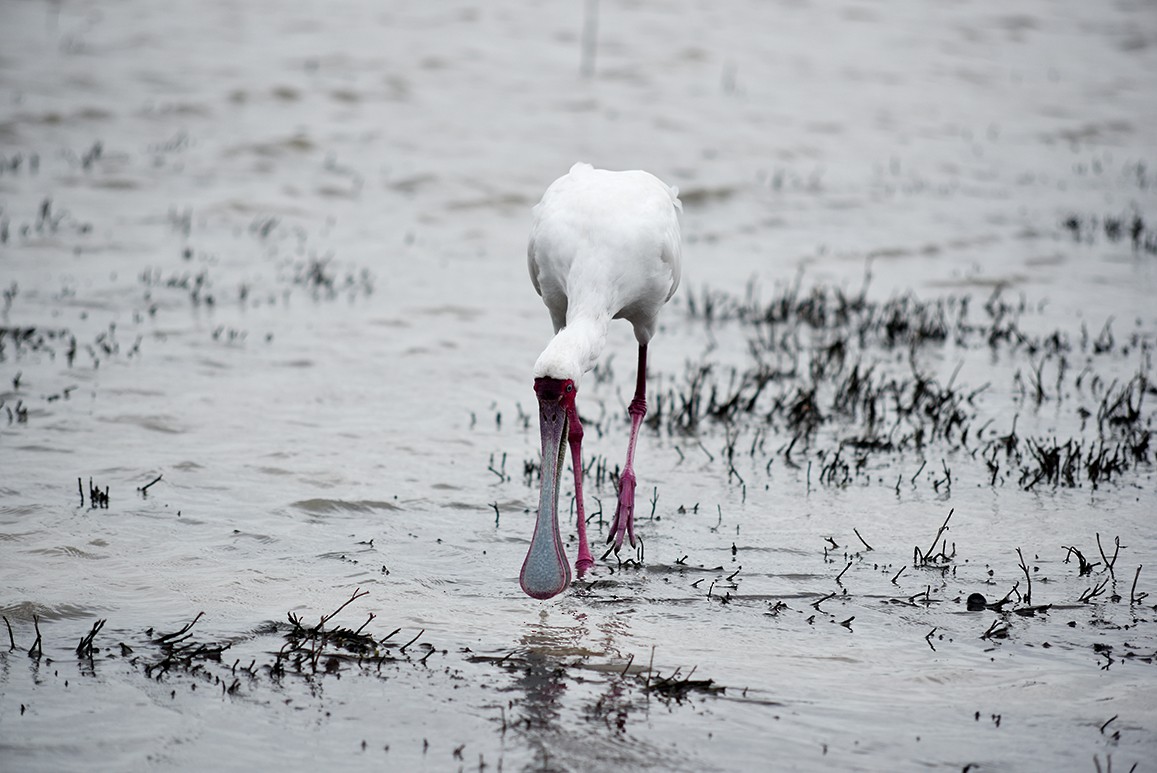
[518, 163, 683, 598]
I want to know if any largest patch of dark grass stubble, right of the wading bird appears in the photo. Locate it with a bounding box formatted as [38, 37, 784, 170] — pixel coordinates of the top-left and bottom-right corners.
[624, 274, 1157, 494]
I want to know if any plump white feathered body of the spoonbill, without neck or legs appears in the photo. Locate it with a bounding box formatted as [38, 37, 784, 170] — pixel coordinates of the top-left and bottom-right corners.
[528, 163, 681, 343]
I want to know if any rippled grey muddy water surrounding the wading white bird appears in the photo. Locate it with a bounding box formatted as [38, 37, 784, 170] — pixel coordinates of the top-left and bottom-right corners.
[0, 1, 1157, 771]
